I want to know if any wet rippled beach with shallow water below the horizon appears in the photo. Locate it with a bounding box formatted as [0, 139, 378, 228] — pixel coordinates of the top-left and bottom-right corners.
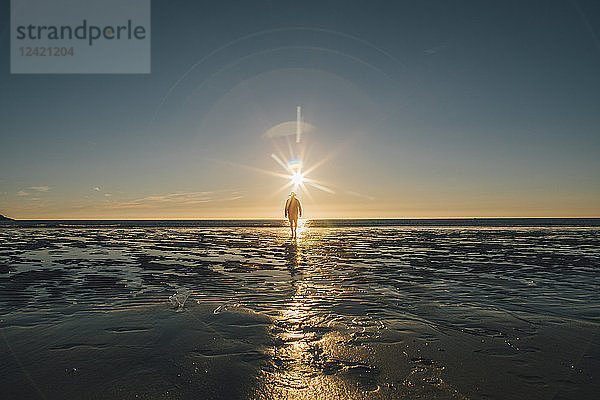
[0, 221, 600, 399]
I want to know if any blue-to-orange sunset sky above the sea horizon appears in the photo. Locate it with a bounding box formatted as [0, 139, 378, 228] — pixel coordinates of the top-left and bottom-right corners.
[0, 0, 600, 219]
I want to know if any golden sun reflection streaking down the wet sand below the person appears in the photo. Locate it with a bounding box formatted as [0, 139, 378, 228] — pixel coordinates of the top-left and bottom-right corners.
[253, 227, 380, 399]
